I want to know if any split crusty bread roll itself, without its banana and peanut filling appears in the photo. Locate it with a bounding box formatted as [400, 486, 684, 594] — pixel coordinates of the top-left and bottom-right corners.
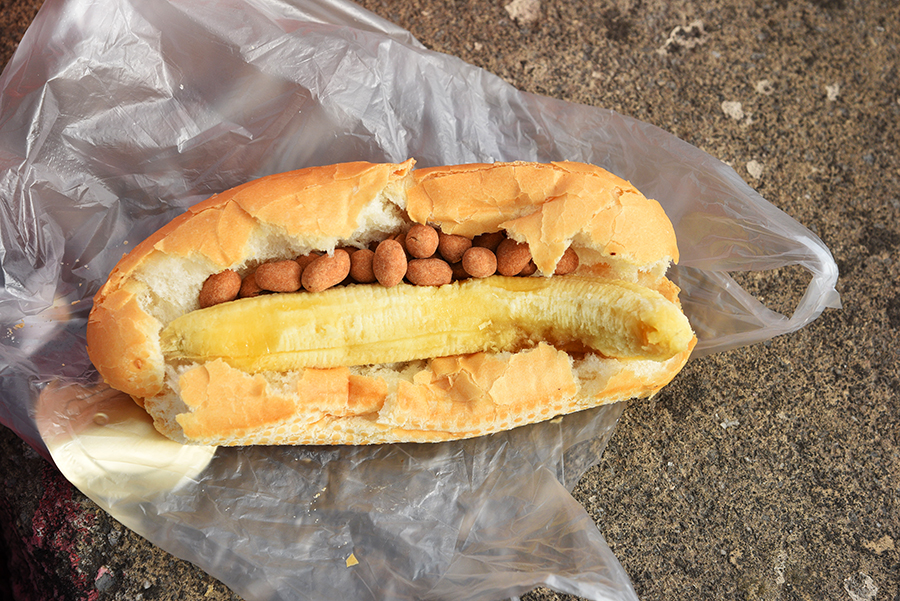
[87, 159, 693, 445]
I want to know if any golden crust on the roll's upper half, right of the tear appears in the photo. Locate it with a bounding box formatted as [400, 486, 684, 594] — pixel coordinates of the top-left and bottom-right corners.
[407, 162, 678, 274]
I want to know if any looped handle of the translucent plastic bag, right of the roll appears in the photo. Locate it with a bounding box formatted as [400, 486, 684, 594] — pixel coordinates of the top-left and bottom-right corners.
[670, 177, 841, 357]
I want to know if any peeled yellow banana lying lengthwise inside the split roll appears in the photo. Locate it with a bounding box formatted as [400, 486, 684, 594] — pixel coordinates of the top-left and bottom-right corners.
[160, 276, 693, 373]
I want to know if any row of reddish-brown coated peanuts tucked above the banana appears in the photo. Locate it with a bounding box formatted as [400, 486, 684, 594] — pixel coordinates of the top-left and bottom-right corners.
[200, 223, 578, 308]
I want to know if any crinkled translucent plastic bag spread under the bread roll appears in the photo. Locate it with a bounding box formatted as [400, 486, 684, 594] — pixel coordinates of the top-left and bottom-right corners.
[0, 0, 839, 600]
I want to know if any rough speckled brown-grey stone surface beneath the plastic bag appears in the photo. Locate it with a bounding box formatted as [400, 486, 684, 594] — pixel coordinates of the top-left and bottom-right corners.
[0, 0, 900, 601]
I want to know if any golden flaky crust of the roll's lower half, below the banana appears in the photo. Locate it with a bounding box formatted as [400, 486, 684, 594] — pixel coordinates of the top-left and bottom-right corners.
[141, 344, 693, 446]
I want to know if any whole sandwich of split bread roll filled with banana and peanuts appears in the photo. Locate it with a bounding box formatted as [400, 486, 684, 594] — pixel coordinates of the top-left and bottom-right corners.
[87, 159, 696, 445]
